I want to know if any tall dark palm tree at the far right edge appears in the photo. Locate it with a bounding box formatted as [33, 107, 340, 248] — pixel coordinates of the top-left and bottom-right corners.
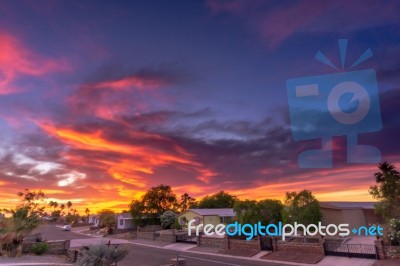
[369, 162, 400, 221]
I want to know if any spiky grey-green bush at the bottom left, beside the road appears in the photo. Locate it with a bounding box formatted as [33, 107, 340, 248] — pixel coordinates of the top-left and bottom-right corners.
[77, 244, 128, 266]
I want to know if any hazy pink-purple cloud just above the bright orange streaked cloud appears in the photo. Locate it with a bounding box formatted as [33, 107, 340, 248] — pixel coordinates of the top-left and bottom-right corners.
[67, 67, 181, 120]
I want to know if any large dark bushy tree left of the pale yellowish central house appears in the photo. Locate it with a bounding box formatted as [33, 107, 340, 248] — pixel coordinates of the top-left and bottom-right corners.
[129, 184, 178, 223]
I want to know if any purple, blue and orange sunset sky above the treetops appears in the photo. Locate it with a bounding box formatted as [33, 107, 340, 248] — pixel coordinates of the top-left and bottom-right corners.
[0, 0, 400, 211]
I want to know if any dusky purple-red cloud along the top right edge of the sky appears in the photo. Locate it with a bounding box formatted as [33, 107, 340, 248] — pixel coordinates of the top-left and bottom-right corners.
[207, 0, 400, 48]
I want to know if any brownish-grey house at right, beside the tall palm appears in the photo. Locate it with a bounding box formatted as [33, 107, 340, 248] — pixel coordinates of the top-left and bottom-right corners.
[320, 201, 383, 228]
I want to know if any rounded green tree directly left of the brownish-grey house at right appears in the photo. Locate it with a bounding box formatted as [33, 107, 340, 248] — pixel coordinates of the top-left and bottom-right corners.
[283, 189, 322, 226]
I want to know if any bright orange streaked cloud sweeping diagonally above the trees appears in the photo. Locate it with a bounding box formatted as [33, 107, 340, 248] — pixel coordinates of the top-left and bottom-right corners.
[36, 122, 217, 189]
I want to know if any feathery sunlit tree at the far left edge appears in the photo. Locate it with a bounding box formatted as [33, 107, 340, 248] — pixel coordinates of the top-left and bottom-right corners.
[0, 189, 46, 256]
